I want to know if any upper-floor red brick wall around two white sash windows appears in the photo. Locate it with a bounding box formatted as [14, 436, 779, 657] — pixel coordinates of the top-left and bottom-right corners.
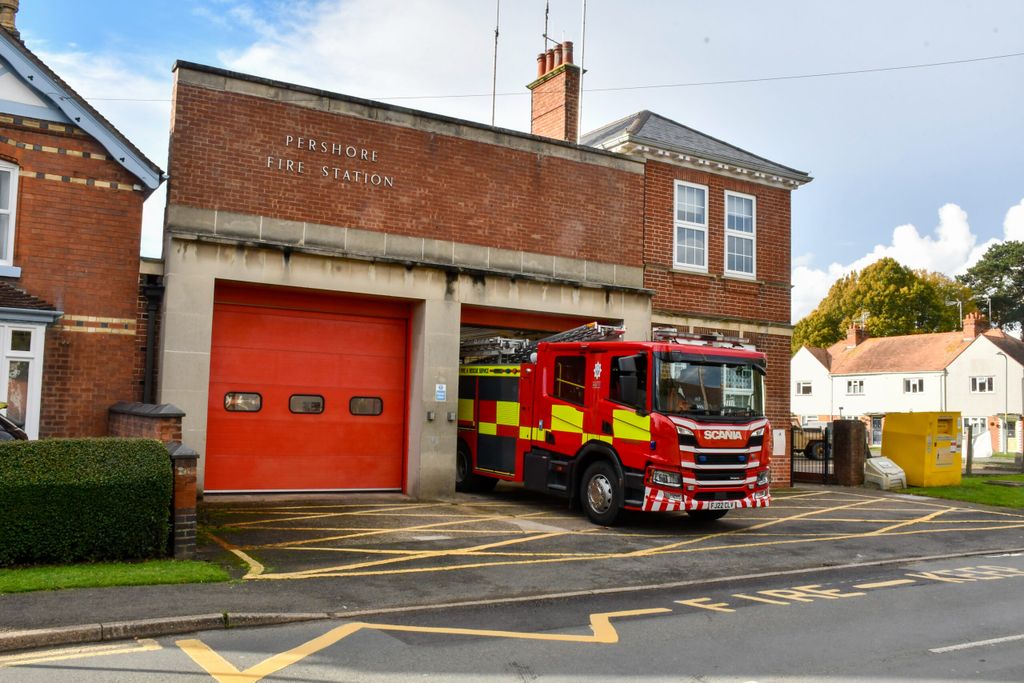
[644, 161, 790, 325]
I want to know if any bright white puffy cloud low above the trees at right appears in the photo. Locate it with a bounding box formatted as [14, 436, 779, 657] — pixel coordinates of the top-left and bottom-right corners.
[793, 200, 1024, 322]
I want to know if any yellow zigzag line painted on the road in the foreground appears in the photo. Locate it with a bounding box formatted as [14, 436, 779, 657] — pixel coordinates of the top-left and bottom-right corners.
[177, 607, 672, 683]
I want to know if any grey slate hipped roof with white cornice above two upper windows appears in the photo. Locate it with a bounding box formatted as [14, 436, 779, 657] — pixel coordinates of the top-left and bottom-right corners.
[580, 110, 812, 182]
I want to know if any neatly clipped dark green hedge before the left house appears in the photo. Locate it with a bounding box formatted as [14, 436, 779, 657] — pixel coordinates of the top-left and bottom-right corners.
[0, 438, 172, 566]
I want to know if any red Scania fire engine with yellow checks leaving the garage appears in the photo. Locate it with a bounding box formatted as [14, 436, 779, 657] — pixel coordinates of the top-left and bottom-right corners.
[456, 324, 771, 524]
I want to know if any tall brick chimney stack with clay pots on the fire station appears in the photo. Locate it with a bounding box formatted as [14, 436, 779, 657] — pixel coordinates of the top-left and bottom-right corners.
[526, 40, 582, 142]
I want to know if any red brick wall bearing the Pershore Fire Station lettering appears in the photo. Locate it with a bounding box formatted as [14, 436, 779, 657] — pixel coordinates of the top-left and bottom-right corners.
[168, 83, 643, 266]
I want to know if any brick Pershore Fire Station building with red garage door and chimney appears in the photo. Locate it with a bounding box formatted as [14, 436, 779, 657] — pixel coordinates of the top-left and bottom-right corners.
[159, 43, 810, 497]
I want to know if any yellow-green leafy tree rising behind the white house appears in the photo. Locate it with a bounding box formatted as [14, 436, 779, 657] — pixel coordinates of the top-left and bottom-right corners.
[793, 258, 977, 352]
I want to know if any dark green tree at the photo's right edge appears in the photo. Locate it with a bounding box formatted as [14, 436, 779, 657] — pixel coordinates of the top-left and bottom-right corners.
[956, 242, 1024, 330]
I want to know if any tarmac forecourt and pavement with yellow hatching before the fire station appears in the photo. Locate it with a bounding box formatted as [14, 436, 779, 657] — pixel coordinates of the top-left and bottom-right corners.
[0, 484, 1024, 651]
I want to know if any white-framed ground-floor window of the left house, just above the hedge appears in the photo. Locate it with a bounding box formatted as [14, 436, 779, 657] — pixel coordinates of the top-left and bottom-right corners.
[0, 324, 44, 438]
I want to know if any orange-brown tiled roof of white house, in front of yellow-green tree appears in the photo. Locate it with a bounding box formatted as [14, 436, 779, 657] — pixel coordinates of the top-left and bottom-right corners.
[828, 331, 974, 375]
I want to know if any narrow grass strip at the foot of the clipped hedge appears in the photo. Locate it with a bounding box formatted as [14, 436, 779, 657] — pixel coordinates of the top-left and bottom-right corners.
[0, 560, 230, 593]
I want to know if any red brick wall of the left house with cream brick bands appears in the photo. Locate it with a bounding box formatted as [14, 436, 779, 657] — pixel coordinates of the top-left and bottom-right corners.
[0, 125, 143, 436]
